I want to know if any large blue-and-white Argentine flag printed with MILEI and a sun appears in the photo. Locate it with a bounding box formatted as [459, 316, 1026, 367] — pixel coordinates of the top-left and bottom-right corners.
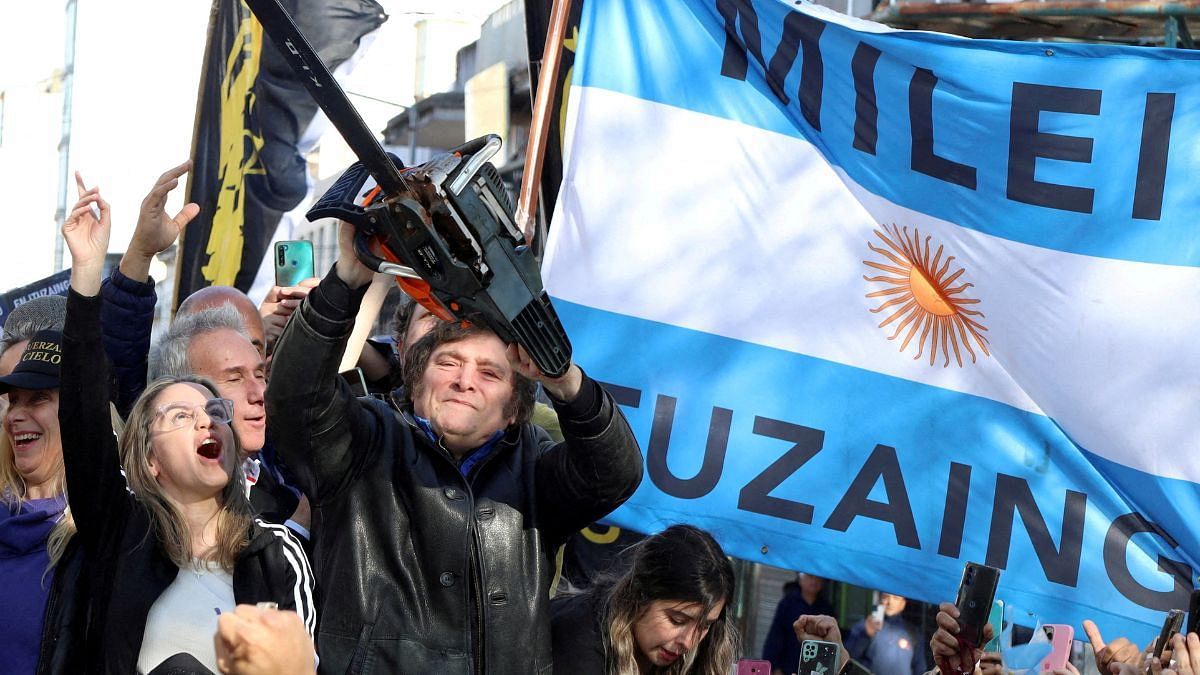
[544, 0, 1200, 643]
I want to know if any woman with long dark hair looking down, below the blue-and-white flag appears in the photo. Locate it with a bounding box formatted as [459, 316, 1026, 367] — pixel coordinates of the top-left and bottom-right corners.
[551, 525, 738, 675]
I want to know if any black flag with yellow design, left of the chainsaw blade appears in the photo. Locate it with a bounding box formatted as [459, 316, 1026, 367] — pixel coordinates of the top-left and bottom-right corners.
[175, 0, 388, 306]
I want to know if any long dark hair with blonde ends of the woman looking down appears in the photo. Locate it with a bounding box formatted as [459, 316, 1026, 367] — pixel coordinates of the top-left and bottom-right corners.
[596, 525, 738, 675]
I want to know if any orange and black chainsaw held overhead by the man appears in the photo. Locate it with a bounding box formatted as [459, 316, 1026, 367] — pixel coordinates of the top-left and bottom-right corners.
[246, 0, 571, 377]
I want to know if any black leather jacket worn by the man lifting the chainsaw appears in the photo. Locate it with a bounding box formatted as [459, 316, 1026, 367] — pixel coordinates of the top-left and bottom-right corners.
[266, 273, 642, 675]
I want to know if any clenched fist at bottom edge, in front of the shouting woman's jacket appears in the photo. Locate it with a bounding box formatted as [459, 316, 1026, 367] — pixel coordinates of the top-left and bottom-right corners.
[214, 604, 316, 675]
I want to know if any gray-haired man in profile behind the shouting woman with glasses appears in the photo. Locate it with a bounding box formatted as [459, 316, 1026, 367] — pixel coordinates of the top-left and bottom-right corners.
[149, 304, 308, 539]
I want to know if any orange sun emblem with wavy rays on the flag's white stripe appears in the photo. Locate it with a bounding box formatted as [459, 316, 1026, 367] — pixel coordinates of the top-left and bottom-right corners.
[863, 225, 990, 368]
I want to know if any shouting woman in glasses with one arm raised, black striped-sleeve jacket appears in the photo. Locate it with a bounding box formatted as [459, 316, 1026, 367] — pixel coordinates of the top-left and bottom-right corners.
[43, 176, 316, 674]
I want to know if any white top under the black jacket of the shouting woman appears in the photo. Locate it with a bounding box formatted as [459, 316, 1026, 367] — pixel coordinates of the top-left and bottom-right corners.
[138, 560, 235, 673]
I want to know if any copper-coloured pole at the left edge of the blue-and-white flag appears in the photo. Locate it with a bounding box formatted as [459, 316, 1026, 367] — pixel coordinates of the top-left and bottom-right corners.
[516, 0, 571, 244]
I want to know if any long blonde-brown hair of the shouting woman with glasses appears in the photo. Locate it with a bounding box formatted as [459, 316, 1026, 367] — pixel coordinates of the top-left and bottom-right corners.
[121, 375, 253, 573]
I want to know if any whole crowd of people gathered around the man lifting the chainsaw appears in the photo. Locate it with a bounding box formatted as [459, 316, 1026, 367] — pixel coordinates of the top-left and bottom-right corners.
[0, 163, 1200, 675]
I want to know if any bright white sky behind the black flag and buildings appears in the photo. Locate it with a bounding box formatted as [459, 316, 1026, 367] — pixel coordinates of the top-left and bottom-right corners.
[0, 0, 505, 292]
